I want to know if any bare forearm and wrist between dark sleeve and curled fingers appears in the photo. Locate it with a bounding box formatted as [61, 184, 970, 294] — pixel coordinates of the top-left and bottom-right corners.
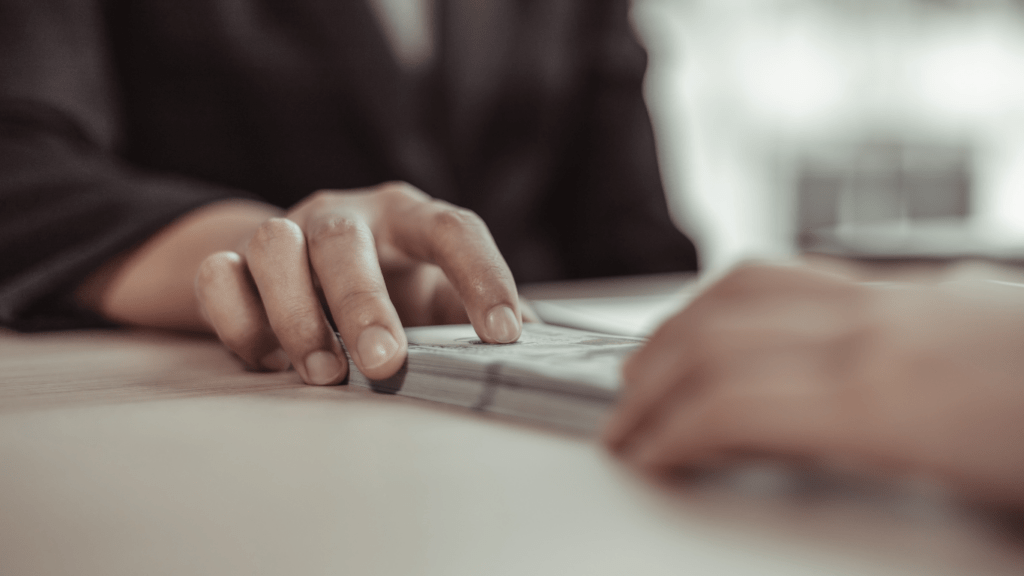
[75, 200, 283, 332]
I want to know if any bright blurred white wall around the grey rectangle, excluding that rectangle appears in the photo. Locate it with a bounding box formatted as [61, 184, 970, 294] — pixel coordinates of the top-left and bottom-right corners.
[633, 0, 1024, 270]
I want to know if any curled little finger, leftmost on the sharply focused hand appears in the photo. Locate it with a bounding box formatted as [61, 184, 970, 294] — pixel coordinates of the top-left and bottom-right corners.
[196, 252, 291, 371]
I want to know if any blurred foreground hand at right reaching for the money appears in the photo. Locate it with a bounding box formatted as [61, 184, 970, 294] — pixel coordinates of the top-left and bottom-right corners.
[605, 265, 1024, 504]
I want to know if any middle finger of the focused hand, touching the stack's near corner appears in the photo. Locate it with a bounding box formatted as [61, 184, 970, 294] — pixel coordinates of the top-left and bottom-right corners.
[305, 209, 409, 379]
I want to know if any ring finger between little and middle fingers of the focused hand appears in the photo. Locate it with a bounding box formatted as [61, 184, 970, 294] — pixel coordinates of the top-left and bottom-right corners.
[246, 218, 348, 385]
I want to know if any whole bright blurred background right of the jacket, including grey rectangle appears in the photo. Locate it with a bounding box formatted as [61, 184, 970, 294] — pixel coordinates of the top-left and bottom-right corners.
[633, 0, 1024, 271]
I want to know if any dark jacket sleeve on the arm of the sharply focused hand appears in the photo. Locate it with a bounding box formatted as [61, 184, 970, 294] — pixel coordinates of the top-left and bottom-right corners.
[0, 0, 238, 330]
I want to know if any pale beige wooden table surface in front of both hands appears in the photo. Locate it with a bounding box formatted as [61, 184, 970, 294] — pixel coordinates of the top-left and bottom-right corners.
[0, 301, 1024, 576]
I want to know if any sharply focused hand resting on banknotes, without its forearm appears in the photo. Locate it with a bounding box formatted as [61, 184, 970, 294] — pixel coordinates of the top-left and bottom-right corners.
[196, 183, 522, 384]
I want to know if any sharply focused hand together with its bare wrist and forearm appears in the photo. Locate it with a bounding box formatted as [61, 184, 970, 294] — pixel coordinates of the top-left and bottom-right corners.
[77, 182, 522, 384]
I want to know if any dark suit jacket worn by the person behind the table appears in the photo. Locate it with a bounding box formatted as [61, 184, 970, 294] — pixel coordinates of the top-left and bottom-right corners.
[0, 0, 696, 328]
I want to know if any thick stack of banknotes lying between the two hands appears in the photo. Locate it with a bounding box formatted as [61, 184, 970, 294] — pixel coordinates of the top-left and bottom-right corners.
[349, 323, 643, 433]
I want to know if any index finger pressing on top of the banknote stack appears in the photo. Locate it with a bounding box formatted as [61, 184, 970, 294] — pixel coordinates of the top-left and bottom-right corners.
[385, 190, 522, 343]
